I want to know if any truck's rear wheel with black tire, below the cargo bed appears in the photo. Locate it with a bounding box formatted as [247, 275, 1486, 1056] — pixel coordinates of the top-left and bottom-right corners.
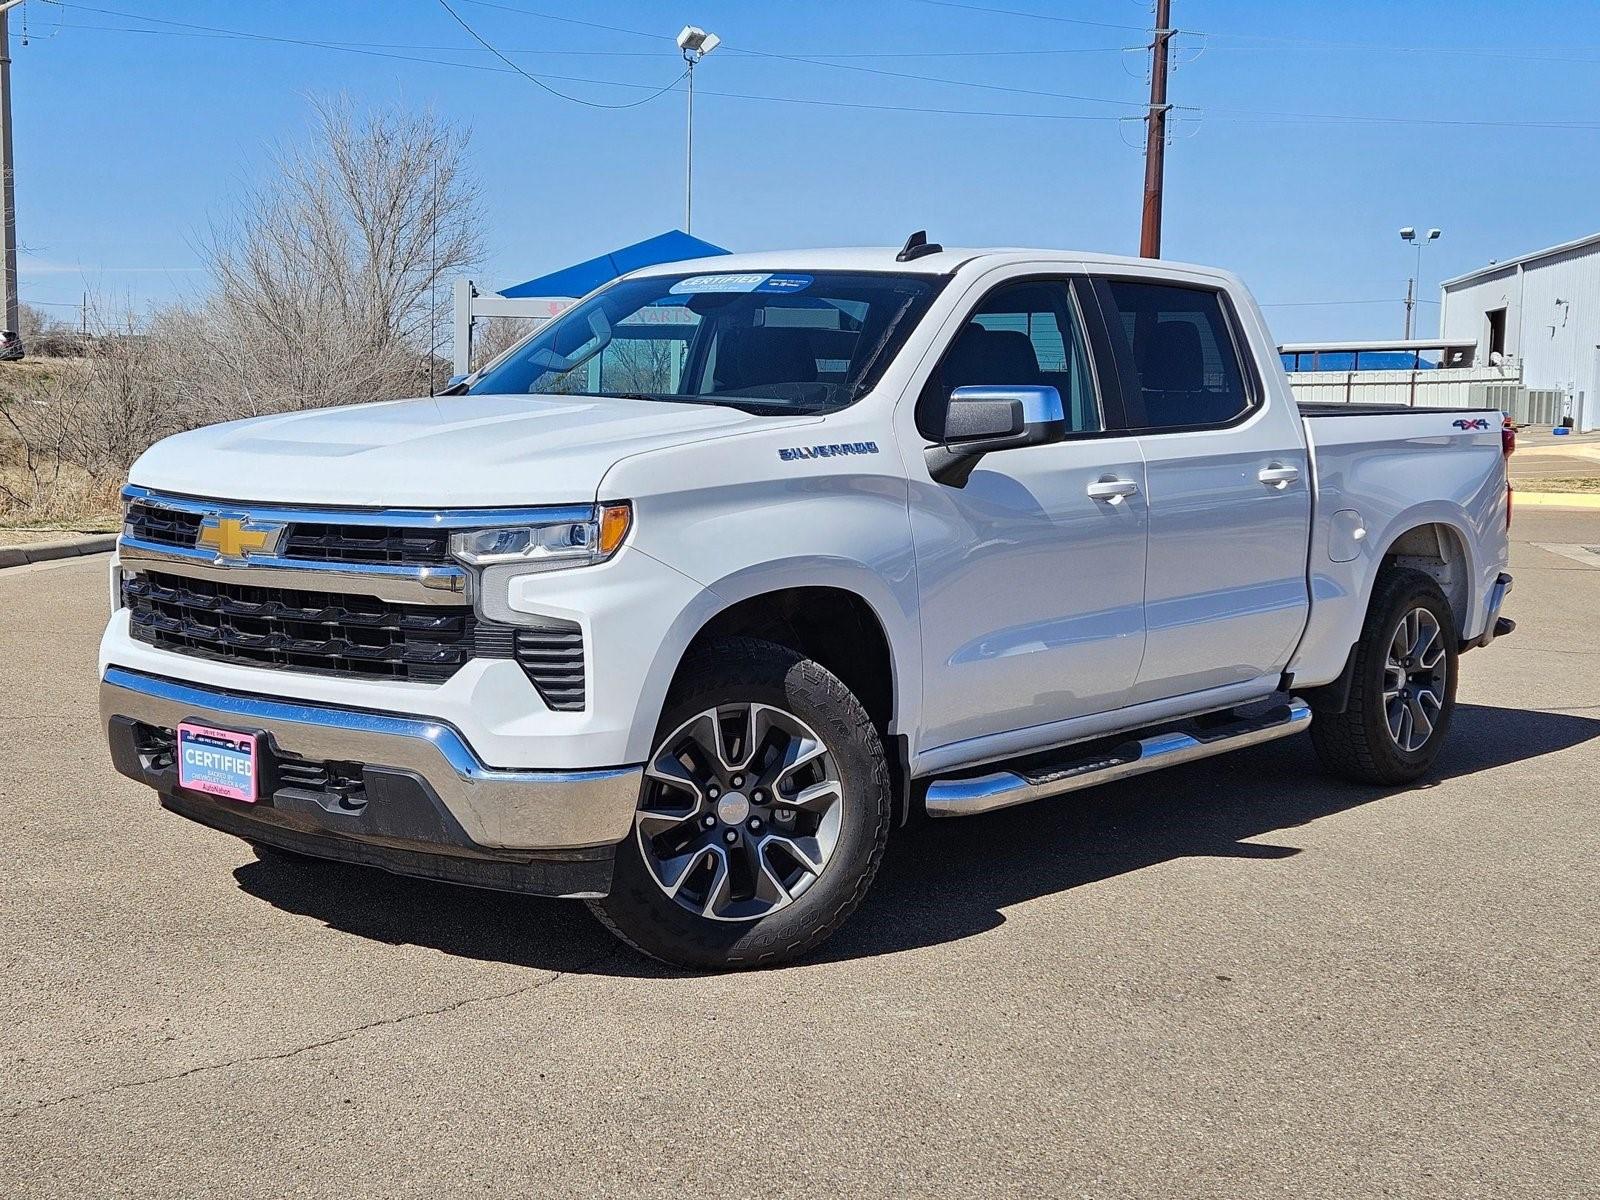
[1310, 568, 1458, 784]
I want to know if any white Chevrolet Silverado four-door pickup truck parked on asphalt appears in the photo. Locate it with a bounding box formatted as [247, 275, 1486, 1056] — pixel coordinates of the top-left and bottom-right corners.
[101, 235, 1512, 968]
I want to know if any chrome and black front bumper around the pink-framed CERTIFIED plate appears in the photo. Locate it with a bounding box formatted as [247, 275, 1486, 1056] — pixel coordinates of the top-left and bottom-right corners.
[101, 666, 642, 894]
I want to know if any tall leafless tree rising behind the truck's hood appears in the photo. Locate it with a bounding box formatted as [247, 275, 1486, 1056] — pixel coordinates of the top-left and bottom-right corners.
[167, 99, 482, 419]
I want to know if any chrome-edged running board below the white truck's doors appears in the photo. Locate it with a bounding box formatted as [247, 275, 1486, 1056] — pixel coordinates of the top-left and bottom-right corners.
[926, 696, 1310, 816]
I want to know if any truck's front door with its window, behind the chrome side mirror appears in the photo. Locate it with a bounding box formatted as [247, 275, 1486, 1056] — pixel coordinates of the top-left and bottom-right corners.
[910, 278, 1149, 749]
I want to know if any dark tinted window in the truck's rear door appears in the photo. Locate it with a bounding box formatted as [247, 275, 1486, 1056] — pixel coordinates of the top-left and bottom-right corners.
[1107, 280, 1250, 429]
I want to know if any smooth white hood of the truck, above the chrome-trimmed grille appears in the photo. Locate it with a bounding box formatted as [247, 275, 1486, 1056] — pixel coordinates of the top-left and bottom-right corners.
[130, 395, 816, 509]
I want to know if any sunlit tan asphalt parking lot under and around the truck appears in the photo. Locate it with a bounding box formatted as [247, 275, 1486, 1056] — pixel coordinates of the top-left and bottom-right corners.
[0, 509, 1600, 1198]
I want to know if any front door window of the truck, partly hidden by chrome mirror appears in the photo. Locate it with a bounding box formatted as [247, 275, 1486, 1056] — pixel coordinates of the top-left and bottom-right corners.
[917, 280, 1101, 442]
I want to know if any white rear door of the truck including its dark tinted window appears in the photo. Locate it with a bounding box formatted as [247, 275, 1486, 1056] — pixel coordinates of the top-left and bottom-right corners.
[1096, 278, 1310, 701]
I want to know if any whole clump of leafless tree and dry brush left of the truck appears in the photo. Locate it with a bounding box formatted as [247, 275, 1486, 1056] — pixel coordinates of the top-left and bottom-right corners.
[0, 99, 482, 515]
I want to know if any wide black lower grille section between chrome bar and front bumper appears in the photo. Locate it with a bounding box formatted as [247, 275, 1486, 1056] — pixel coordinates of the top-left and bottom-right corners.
[123, 571, 504, 683]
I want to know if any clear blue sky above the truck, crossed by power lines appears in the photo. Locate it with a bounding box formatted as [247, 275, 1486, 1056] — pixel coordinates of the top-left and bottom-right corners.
[11, 0, 1600, 339]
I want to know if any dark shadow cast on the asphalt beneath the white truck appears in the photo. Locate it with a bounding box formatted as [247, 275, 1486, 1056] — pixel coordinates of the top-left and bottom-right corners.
[234, 704, 1600, 976]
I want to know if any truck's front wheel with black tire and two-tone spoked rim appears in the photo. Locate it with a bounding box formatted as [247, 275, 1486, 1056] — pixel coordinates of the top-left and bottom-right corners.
[589, 637, 893, 970]
